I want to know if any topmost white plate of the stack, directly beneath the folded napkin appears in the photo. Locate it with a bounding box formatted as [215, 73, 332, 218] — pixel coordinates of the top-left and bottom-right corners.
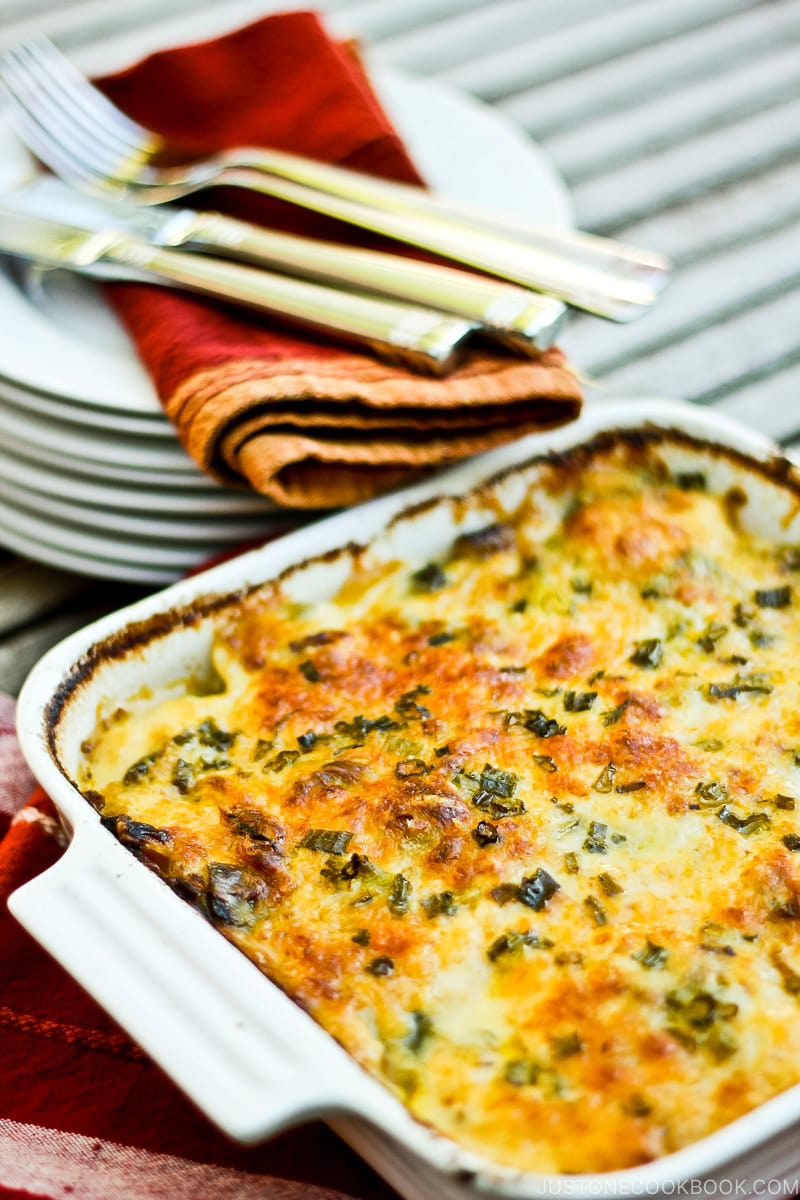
[0, 67, 571, 416]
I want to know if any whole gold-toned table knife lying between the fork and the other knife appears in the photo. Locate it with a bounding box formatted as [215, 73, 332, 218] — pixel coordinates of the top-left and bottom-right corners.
[6, 175, 566, 355]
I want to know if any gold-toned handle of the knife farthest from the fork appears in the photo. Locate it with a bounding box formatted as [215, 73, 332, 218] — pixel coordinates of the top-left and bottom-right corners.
[102, 235, 475, 376]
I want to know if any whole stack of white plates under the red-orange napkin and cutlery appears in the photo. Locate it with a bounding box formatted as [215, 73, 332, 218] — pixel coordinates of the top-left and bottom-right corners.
[0, 72, 570, 583]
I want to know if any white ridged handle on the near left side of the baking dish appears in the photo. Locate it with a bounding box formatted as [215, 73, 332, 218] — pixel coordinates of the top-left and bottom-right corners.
[8, 821, 369, 1142]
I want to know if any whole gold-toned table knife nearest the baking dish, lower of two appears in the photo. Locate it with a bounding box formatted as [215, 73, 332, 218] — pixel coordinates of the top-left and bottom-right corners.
[0, 205, 476, 374]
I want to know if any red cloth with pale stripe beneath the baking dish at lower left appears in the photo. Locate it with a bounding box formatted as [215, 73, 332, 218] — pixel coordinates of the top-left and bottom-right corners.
[0, 697, 396, 1200]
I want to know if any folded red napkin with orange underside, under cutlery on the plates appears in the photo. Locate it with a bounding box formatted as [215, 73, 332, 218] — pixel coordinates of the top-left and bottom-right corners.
[98, 12, 581, 508]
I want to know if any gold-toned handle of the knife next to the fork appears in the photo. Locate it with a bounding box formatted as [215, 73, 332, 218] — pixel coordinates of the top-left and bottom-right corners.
[160, 210, 566, 355]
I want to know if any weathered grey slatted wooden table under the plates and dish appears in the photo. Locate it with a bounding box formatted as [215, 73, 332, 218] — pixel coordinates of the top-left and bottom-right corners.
[0, 0, 800, 691]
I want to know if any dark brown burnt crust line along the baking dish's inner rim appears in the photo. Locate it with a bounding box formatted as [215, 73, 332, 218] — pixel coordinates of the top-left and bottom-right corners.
[43, 422, 800, 782]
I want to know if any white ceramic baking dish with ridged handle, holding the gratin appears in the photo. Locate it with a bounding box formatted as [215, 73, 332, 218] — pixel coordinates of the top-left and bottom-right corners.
[11, 401, 800, 1200]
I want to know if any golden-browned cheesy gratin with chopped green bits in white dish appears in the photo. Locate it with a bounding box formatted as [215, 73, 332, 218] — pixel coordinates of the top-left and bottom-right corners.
[80, 433, 800, 1171]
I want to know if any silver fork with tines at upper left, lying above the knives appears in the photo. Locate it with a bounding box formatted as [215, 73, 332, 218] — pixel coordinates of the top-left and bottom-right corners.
[0, 37, 669, 320]
